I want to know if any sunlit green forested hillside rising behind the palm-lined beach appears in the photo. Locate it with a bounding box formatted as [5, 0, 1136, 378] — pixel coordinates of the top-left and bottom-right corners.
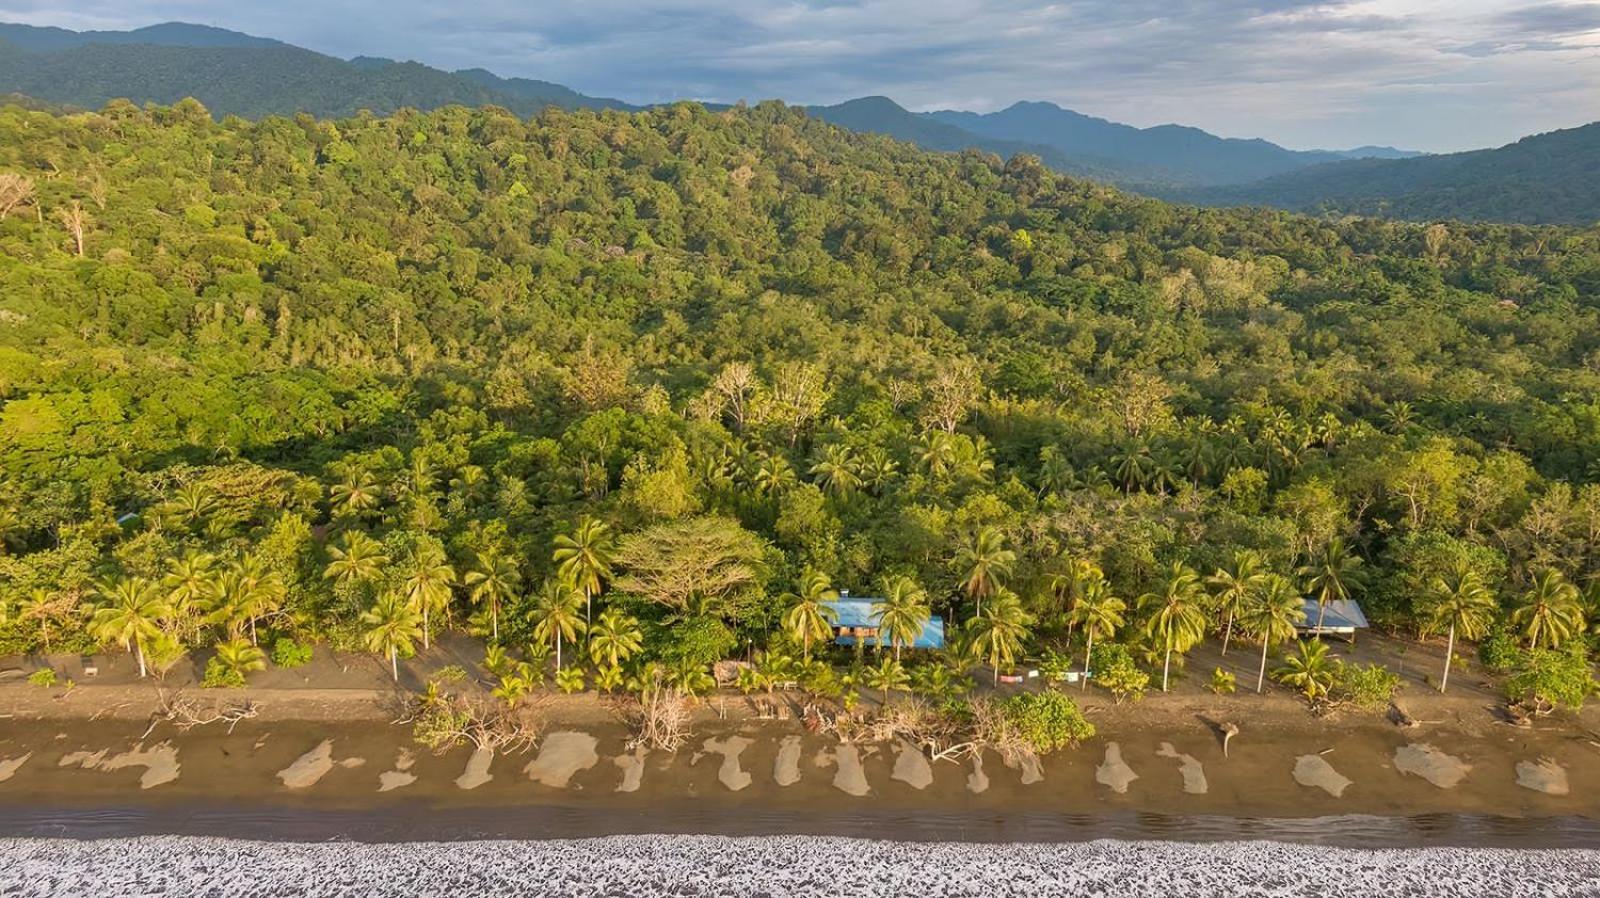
[0, 101, 1600, 701]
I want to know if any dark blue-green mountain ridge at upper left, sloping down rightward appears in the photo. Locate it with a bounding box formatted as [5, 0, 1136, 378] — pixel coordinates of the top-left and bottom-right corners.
[0, 22, 634, 118]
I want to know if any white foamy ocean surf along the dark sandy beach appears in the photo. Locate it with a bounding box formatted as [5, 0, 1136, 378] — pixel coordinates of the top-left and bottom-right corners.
[0, 836, 1600, 898]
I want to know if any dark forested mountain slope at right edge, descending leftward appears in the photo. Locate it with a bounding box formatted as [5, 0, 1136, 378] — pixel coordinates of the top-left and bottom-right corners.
[1166, 122, 1600, 226]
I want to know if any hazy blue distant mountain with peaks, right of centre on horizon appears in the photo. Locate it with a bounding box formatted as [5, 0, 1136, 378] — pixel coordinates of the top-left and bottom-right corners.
[925, 102, 1403, 187]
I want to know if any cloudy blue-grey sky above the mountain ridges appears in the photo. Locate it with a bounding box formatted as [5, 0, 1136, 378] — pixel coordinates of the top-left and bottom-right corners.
[0, 0, 1600, 152]
